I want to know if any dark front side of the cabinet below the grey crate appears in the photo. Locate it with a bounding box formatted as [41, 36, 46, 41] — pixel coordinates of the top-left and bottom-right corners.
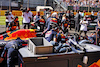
[19, 49, 100, 67]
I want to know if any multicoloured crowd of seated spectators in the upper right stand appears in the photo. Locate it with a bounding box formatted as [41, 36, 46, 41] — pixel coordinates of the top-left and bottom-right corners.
[58, 0, 100, 7]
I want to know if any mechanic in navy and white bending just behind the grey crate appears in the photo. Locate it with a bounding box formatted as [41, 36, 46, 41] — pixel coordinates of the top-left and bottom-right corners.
[45, 22, 61, 46]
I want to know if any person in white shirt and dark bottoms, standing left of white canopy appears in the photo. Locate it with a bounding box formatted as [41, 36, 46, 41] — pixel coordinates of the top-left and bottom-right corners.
[22, 9, 32, 29]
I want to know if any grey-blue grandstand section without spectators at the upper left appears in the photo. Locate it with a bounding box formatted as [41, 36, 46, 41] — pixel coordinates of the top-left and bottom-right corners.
[0, 0, 53, 10]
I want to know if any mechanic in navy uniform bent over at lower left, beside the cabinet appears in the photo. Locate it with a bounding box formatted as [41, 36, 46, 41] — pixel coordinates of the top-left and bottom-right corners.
[0, 37, 25, 67]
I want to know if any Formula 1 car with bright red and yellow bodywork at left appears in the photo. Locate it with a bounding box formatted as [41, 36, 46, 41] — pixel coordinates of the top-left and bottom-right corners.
[0, 29, 36, 67]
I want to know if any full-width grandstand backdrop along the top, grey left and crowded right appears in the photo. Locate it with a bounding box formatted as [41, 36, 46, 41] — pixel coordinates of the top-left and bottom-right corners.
[0, 0, 100, 11]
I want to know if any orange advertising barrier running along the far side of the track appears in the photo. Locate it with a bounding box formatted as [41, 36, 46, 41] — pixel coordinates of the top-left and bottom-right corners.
[0, 10, 97, 16]
